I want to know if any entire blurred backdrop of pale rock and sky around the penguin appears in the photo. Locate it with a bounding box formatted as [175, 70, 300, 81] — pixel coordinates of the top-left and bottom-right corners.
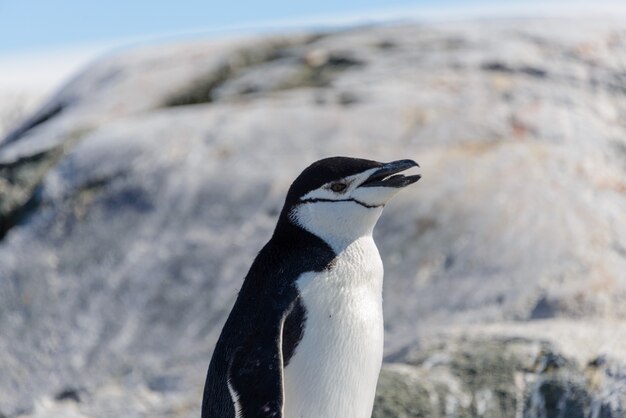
[0, 0, 626, 418]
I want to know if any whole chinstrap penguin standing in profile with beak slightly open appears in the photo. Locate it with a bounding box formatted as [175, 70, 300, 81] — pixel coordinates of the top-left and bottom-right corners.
[202, 157, 421, 418]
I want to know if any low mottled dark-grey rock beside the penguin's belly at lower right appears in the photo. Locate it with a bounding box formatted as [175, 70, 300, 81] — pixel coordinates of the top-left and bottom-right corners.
[372, 338, 626, 418]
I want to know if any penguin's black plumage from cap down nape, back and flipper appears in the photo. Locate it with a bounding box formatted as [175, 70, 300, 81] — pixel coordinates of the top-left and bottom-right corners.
[202, 157, 381, 418]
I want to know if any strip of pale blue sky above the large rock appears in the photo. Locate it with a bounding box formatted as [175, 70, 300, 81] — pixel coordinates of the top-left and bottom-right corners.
[0, 0, 438, 54]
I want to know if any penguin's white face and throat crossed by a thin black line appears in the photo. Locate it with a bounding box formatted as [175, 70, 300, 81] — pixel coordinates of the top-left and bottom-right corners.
[290, 168, 402, 251]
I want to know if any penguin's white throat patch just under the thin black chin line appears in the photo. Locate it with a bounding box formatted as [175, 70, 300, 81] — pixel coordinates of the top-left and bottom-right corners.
[281, 203, 383, 254]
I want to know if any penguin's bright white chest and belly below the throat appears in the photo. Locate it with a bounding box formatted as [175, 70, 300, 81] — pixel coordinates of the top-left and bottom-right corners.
[284, 236, 383, 418]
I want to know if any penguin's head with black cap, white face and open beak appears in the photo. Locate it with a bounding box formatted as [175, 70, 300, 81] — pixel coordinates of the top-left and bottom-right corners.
[283, 157, 421, 246]
